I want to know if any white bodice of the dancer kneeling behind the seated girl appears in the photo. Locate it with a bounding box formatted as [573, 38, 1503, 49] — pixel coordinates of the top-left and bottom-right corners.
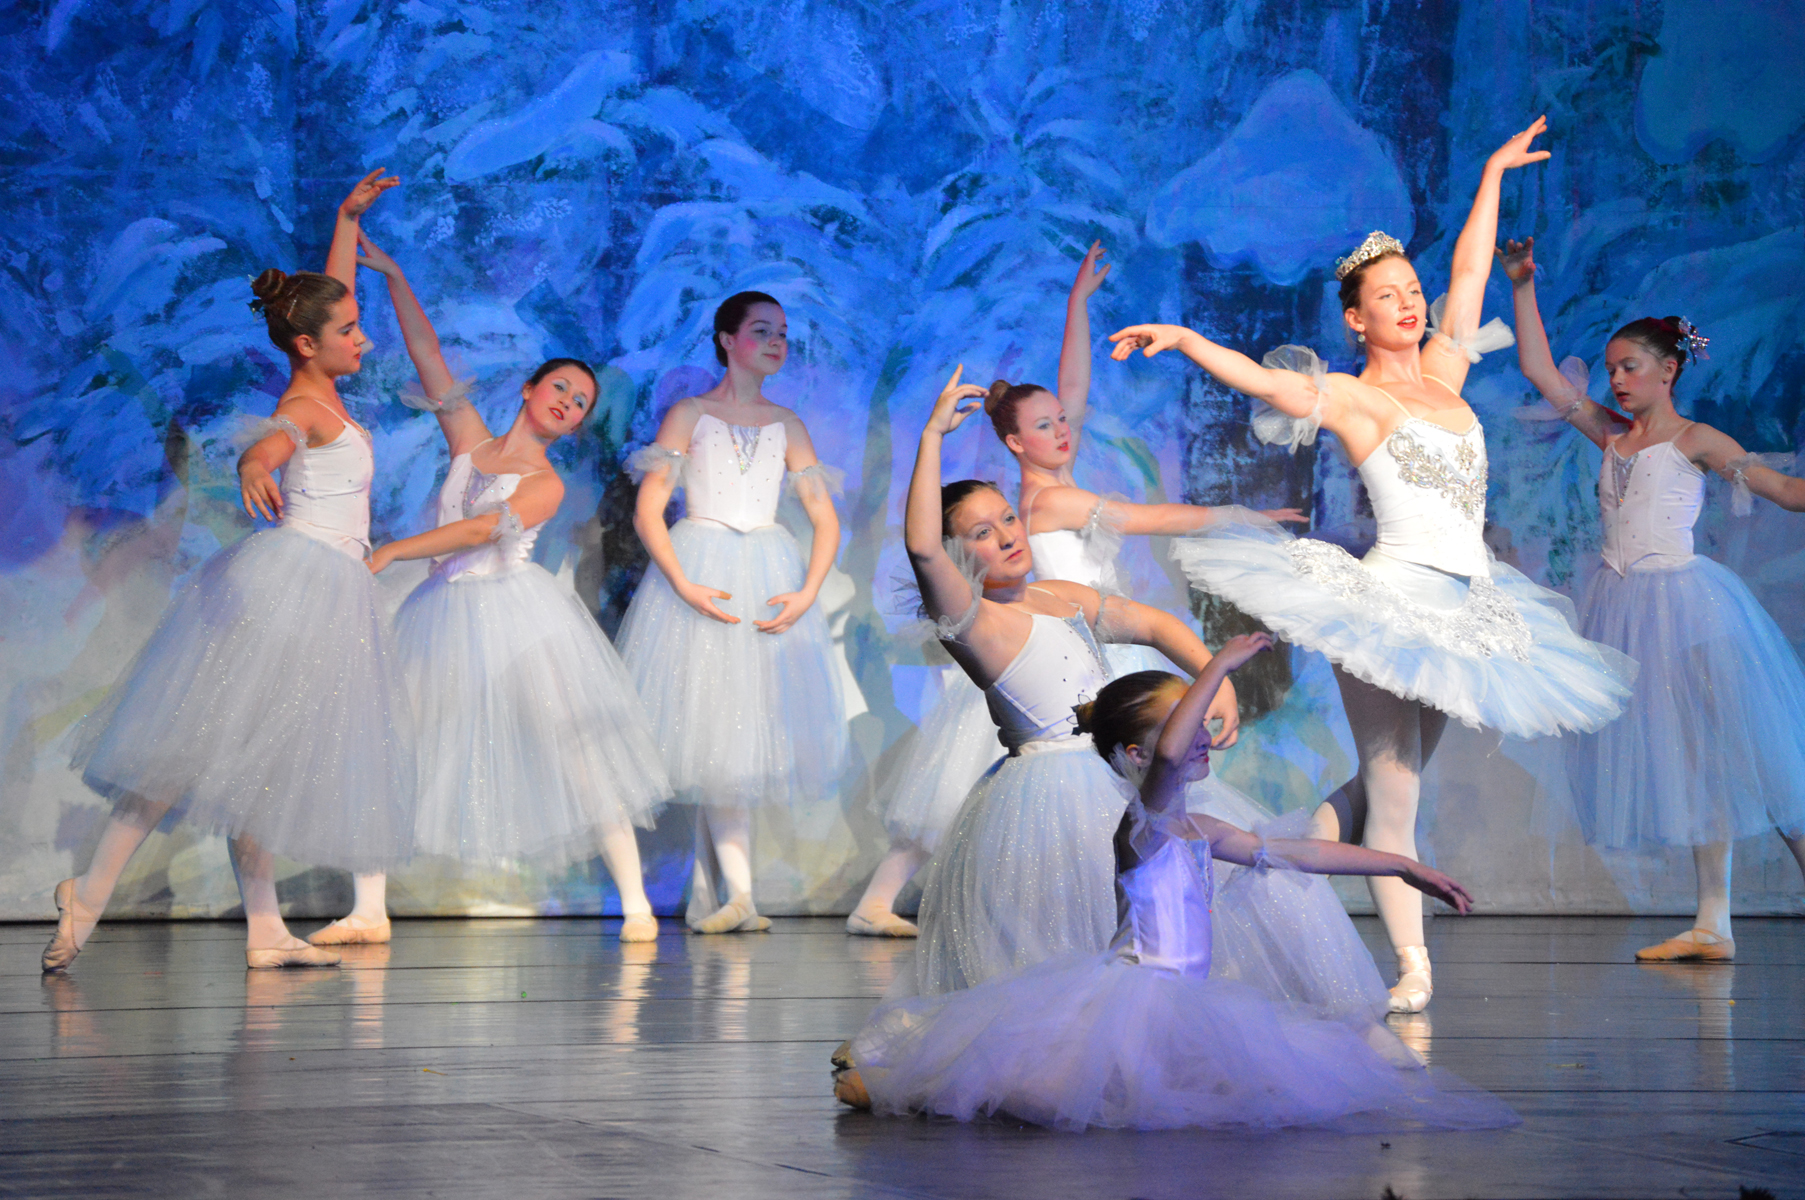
[984, 612, 1110, 754]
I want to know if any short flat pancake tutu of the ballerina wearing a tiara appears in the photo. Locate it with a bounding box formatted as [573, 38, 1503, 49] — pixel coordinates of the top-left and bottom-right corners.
[1171, 522, 1635, 738]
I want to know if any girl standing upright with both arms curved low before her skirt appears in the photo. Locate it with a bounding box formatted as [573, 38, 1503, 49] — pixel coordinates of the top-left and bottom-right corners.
[619, 292, 847, 933]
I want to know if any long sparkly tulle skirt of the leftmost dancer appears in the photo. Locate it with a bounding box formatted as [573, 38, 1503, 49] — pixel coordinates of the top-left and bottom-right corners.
[74, 529, 413, 872]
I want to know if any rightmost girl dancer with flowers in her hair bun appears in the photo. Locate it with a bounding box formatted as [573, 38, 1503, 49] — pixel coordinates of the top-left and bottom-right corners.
[1498, 238, 1805, 962]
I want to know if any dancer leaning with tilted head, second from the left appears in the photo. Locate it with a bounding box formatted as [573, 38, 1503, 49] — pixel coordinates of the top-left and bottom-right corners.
[307, 235, 670, 946]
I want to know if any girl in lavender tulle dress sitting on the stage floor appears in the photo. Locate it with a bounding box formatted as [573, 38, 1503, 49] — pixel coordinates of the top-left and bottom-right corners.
[836, 633, 1516, 1131]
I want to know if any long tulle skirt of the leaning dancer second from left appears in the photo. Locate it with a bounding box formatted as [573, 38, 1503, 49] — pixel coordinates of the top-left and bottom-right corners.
[395, 563, 670, 864]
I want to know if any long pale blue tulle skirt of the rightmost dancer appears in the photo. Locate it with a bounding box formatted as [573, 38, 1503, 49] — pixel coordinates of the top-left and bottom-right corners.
[1567, 558, 1805, 846]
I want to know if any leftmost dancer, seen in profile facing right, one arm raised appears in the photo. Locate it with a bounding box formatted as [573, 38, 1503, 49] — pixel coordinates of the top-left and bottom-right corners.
[43, 170, 413, 971]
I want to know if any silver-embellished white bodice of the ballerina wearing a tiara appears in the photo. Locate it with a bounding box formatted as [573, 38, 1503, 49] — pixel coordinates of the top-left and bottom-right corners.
[1359, 417, 1491, 577]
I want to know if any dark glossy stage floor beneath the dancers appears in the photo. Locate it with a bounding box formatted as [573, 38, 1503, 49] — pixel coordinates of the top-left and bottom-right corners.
[0, 917, 1805, 1200]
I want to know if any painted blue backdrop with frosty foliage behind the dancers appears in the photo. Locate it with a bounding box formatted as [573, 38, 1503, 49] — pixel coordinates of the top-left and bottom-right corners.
[0, 0, 1805, 917]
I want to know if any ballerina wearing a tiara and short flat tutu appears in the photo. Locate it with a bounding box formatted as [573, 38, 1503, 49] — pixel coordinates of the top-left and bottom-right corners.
[1110, 119, 1634, 1012]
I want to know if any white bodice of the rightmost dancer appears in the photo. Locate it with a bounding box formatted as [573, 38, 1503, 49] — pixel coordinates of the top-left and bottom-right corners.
[1597, 438, 1704, 576]
